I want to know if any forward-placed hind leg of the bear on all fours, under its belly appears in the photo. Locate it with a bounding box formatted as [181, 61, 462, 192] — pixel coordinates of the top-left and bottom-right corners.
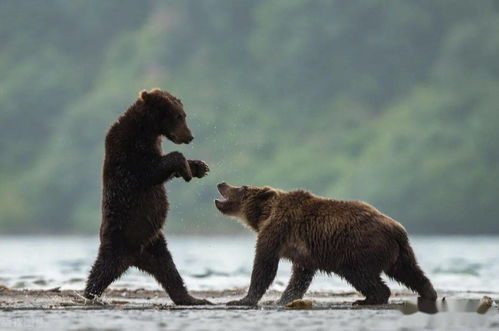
[344, 272, 390, 305]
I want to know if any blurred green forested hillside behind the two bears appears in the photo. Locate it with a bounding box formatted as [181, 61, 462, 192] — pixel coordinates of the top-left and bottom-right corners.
[0, 0, 499, 234]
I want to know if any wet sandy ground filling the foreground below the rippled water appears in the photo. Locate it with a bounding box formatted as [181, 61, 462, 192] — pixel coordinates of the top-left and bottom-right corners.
[0, 287, 499, 330]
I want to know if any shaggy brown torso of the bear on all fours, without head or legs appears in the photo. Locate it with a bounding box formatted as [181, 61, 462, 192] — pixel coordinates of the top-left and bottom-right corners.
[276, 192, 407, 272]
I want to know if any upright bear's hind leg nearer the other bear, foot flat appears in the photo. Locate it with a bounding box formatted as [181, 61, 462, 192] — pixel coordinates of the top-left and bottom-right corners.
[134, 235, 211, 306]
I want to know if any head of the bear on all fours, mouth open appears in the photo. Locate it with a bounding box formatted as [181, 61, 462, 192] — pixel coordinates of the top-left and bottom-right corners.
[215, 183, 278, 232]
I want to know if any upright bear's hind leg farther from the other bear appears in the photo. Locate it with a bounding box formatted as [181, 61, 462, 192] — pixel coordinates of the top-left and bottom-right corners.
[83, 246, 130, 299]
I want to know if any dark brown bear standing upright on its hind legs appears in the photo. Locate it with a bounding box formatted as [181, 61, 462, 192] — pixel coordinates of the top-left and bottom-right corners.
[85, 89, 209, 305]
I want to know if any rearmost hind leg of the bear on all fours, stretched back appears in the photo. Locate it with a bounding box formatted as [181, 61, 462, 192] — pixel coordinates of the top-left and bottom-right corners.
[385, 231, 437, 300]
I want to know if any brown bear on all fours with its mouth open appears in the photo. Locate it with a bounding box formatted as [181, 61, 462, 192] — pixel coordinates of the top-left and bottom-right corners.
[215, 183, 437, 305]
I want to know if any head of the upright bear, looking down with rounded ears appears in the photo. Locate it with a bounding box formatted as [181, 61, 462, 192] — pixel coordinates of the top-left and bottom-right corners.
[140, 89, 194, 144]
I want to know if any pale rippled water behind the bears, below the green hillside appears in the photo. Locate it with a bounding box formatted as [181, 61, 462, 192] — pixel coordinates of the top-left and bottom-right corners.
[0, 236, 499, 292]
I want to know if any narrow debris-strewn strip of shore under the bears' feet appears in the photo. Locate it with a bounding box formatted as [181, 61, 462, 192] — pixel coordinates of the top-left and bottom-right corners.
[0, 287, 499, 311]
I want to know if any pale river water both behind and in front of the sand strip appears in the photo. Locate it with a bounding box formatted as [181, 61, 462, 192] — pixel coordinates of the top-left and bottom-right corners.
[0, 236, 499, 330]
